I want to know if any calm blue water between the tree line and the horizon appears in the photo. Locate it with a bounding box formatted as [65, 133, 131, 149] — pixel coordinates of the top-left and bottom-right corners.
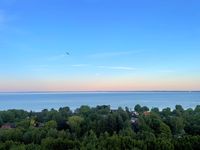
[0, 92, 200, 111]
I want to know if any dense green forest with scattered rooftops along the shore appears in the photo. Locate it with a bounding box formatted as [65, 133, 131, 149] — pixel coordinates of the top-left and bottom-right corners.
[0, 105, 200, 150]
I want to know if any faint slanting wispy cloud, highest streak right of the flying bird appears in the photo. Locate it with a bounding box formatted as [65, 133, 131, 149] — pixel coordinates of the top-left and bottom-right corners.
[89, 50, 143, 58]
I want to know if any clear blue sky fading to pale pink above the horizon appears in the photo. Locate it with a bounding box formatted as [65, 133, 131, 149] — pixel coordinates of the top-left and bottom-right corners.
[0, 0, 200, 92]
